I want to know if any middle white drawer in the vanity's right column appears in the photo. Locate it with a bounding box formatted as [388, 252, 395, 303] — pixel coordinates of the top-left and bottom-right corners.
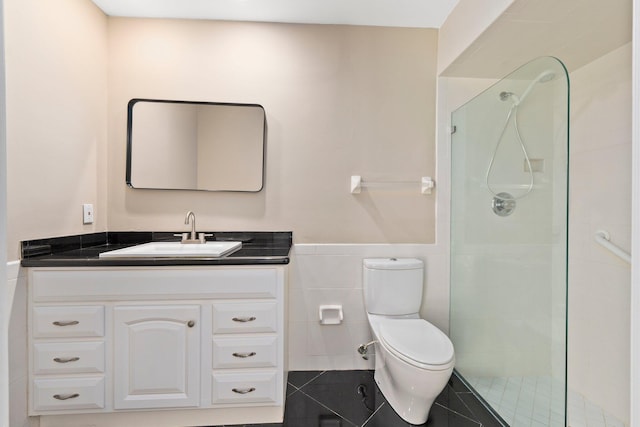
[213, 336, 278, 369]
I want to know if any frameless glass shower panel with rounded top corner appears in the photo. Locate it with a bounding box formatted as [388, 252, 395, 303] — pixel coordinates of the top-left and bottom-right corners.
[450, 57, 569, 427]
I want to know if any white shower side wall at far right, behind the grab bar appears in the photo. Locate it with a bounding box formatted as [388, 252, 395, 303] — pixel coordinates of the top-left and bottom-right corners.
[568, 44, 631, 425]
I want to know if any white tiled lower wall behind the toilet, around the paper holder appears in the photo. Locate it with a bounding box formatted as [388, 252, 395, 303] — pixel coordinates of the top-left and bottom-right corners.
[288, 244, 449, 371]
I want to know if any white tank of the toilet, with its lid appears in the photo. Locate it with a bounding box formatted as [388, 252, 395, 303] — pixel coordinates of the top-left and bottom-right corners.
[362, 258, 424, 316]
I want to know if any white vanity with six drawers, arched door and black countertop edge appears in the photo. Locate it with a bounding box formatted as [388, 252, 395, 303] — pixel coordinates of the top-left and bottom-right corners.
[23, 233, 291, 427]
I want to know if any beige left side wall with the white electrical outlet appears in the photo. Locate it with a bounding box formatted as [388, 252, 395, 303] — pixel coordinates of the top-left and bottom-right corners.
[4, 0, 107, 260]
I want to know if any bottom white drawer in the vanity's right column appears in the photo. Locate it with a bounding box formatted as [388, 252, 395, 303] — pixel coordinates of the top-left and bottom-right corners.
[211, 370, 278, 405]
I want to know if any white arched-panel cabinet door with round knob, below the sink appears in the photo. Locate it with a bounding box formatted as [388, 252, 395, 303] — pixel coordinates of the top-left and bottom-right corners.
[113, 305, 200, 409]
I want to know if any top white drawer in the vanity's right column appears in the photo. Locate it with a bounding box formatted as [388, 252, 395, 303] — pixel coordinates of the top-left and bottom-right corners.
[213, 301, 278, 334]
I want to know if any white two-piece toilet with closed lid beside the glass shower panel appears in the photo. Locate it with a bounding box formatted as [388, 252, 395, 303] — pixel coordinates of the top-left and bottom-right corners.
[363, 258, 454, 424]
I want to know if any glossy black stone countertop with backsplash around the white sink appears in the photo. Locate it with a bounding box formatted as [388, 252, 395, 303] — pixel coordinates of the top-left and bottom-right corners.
[21, 231, 293, 267]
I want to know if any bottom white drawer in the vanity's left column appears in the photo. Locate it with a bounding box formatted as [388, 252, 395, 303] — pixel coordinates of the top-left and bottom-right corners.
[33, 376, 104, 411]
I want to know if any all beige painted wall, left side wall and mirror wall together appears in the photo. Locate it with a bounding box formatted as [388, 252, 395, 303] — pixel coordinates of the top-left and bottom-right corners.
[5, 7, 437, 254]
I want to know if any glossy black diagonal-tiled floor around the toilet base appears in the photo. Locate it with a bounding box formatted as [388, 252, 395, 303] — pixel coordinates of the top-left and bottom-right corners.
[208, 371, 500, 427]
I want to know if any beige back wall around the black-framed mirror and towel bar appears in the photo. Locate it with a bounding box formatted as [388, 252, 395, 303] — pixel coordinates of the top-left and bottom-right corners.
[108, 18, 437, 243]
